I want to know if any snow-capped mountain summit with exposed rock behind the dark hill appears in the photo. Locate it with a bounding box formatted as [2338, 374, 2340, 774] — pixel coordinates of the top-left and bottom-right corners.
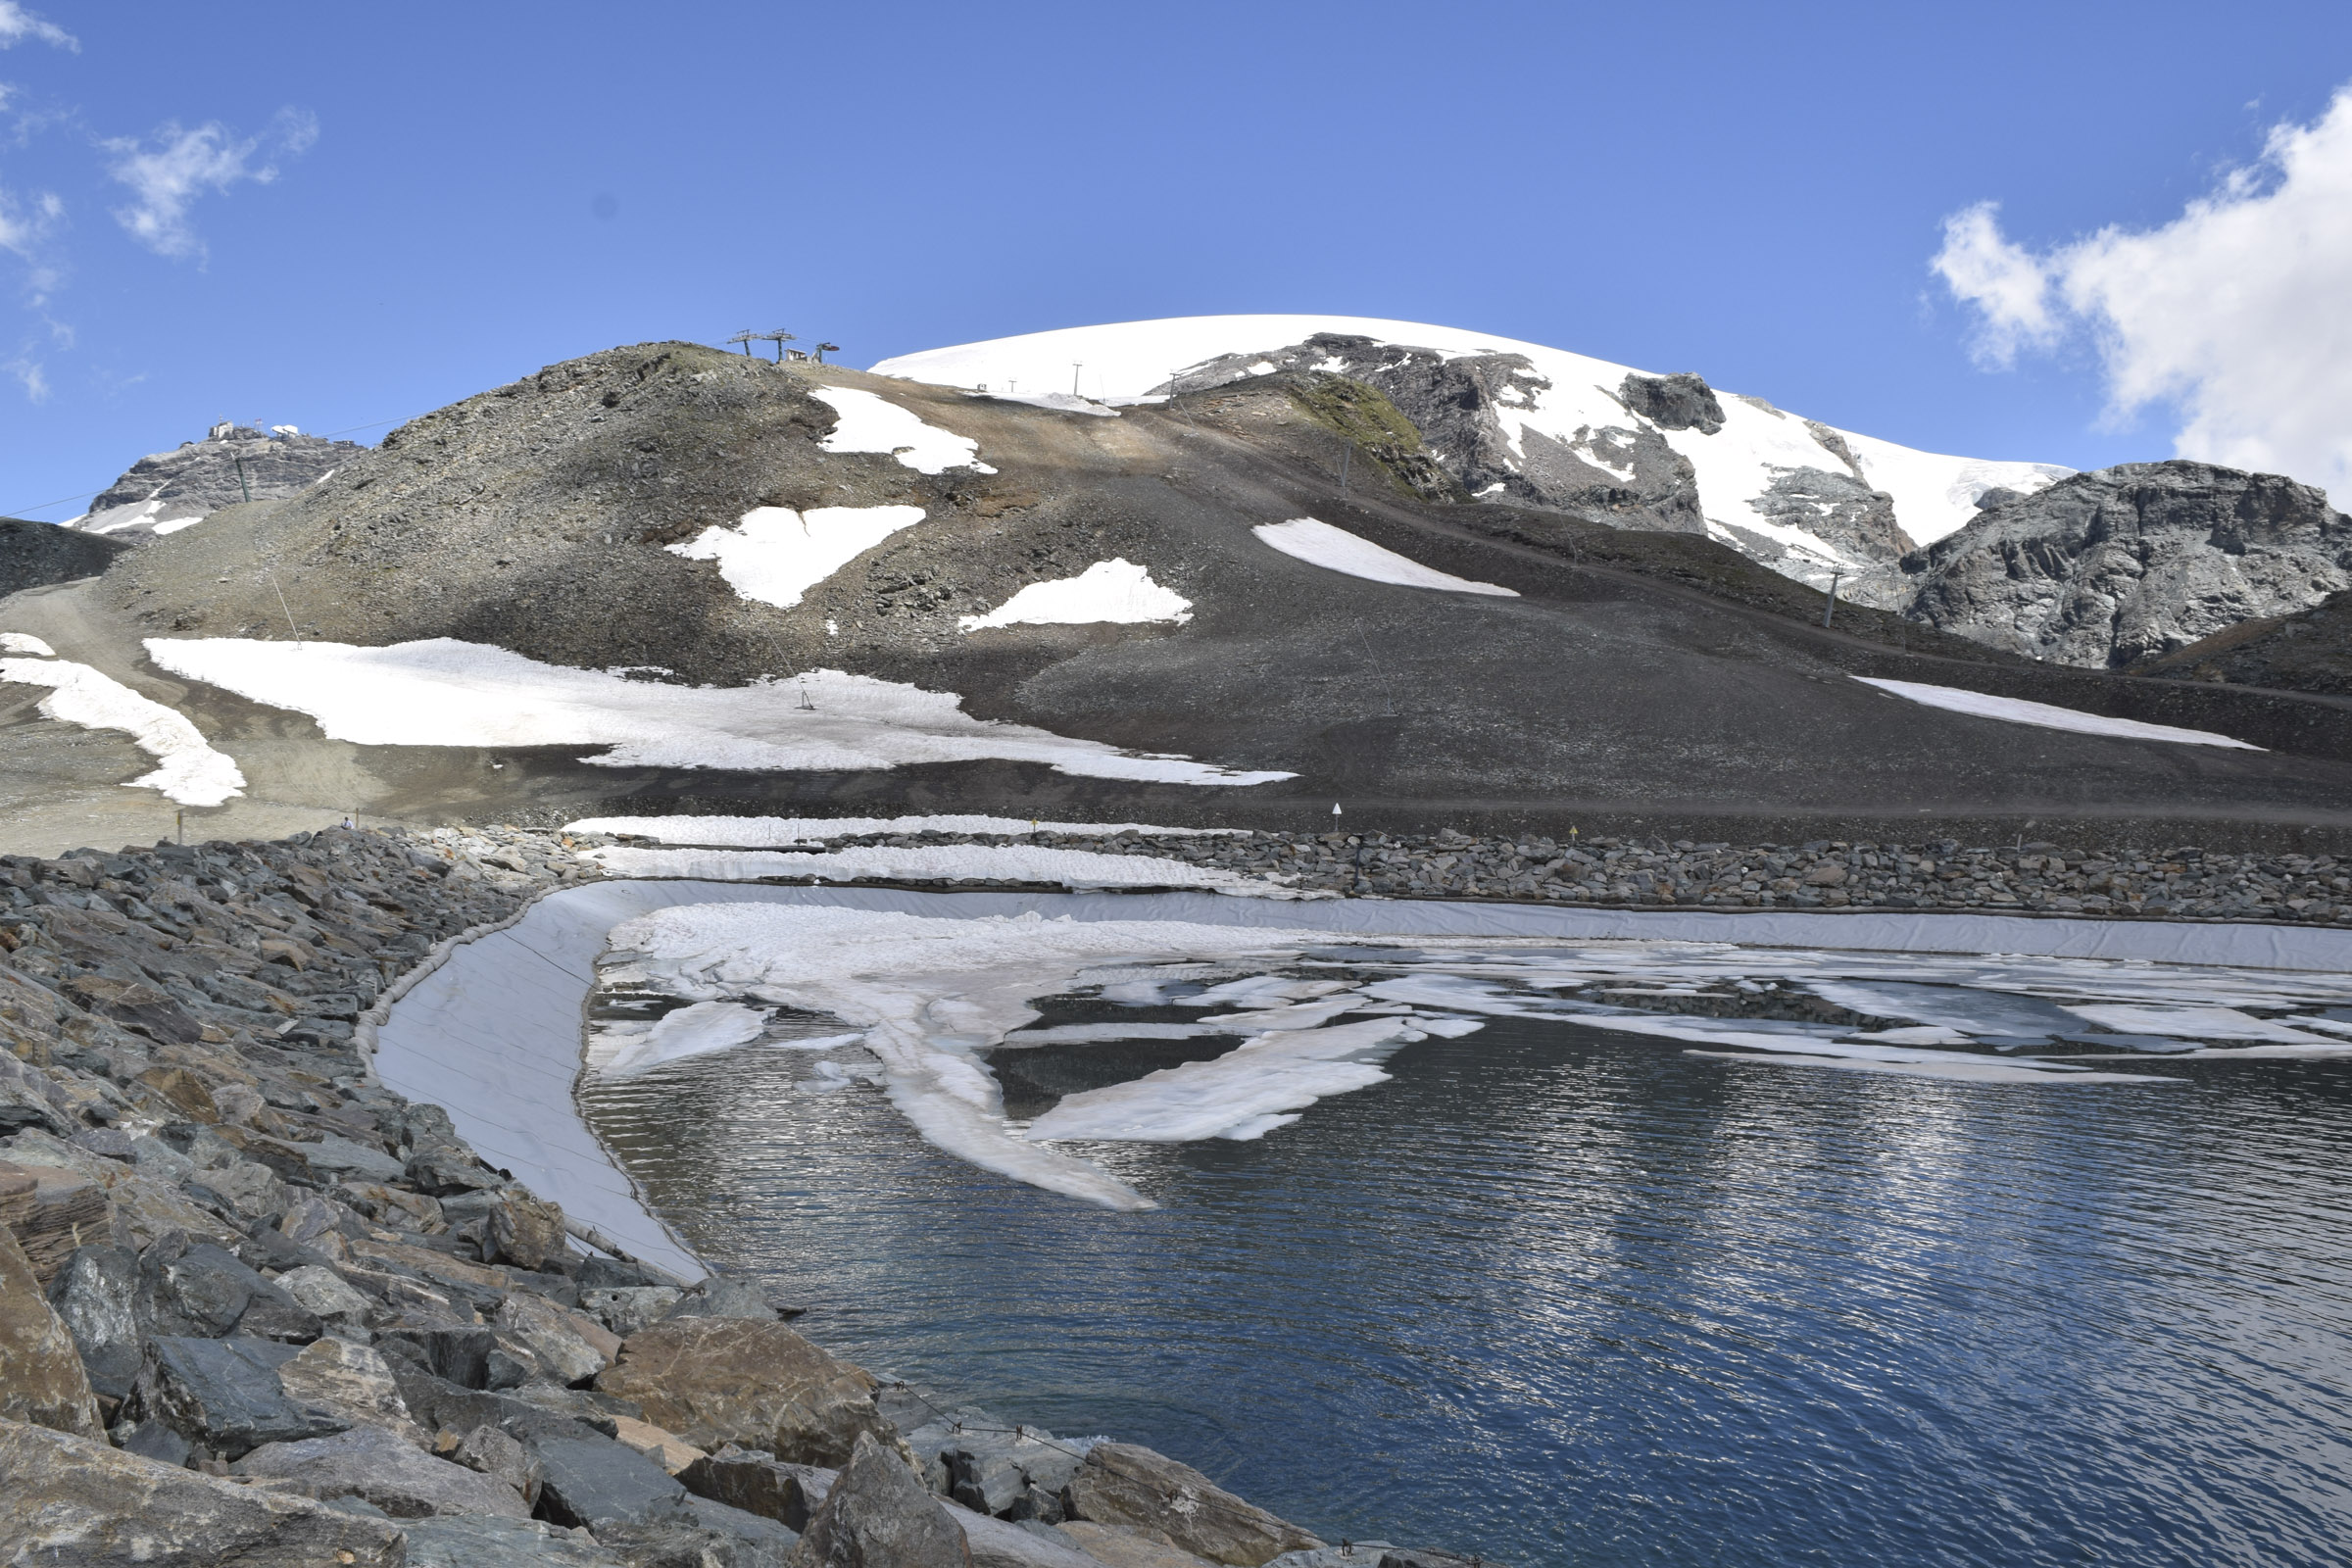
[872, 315, 2072, 602]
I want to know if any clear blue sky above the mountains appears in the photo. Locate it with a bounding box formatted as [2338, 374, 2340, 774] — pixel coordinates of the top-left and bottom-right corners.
[0, 0, 2352, 519]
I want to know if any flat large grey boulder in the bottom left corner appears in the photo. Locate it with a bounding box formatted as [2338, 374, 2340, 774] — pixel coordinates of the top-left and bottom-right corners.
[0, 1420, 402, 1568]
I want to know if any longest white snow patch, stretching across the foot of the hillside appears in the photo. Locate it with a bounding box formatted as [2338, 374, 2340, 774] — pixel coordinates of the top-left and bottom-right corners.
[146, 637, 1289, 785]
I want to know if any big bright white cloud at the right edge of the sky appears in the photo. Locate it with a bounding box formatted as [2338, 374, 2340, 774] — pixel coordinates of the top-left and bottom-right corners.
[1934, 87, 2352, 506]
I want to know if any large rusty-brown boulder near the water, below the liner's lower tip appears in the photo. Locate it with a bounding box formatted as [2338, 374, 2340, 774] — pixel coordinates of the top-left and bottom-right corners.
[595, 1316, 896, 1464]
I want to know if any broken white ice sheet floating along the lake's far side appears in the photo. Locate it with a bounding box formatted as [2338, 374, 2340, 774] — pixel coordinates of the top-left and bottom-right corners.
[588, 903, 2352, 1208]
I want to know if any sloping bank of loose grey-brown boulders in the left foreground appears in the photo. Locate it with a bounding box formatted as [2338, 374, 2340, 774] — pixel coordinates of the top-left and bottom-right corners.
[0, 830, 1458, 1568]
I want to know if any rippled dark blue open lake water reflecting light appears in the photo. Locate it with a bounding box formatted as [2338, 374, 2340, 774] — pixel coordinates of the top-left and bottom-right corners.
[583, 1018, 2352, 1568]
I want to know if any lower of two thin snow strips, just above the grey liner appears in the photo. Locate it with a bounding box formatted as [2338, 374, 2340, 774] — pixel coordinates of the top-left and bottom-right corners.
[588, 844, 1339, 898]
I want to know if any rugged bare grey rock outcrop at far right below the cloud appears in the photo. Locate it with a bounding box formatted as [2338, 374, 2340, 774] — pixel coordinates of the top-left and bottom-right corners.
[1903, 461, 2352, 667]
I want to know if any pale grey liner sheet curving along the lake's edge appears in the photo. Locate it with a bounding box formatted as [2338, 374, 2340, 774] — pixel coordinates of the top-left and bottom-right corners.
[376, 882, 2352, 1279]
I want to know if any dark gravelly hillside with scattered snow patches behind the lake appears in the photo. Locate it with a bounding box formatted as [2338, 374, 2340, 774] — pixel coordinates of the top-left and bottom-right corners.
[23, 343, 2352, 847]
